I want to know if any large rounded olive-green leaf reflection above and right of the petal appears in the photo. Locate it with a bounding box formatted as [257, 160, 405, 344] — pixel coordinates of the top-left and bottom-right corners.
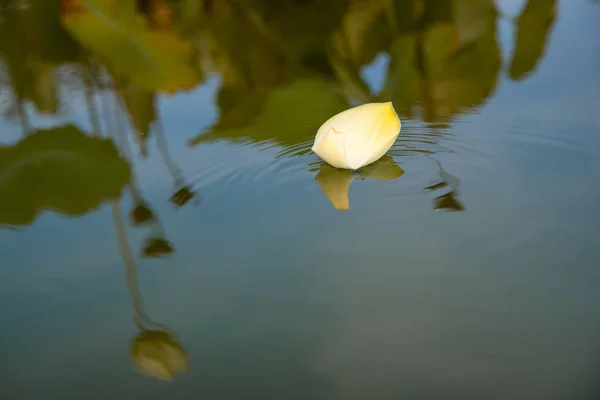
[382, 0, 502, 121]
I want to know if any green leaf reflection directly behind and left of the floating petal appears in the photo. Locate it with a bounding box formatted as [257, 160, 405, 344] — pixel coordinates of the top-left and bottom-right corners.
[192, 79, 346, 145]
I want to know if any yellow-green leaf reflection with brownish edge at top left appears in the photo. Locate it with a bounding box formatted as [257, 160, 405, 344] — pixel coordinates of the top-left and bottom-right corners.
[62, 0, 199, 92]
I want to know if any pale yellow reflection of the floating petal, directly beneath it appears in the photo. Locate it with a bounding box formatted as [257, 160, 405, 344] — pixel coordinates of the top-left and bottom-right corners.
[315, 156, 404, 210]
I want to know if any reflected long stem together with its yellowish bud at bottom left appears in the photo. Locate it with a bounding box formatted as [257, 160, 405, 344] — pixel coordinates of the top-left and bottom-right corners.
[112, 203, 188, 380]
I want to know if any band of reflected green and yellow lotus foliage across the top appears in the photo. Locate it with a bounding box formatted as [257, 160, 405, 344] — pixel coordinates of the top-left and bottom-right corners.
[0, 0, 556, 148]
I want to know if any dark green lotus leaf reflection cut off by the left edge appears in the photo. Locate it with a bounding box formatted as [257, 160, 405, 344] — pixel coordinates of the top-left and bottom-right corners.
[0, 125, 130, 225]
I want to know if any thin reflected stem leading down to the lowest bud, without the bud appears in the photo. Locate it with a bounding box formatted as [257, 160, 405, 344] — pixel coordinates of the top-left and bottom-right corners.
[112, 202, 152, 330]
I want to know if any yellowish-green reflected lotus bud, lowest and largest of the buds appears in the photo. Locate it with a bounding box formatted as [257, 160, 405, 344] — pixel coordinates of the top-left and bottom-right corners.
[130, 331, 187, 381]
